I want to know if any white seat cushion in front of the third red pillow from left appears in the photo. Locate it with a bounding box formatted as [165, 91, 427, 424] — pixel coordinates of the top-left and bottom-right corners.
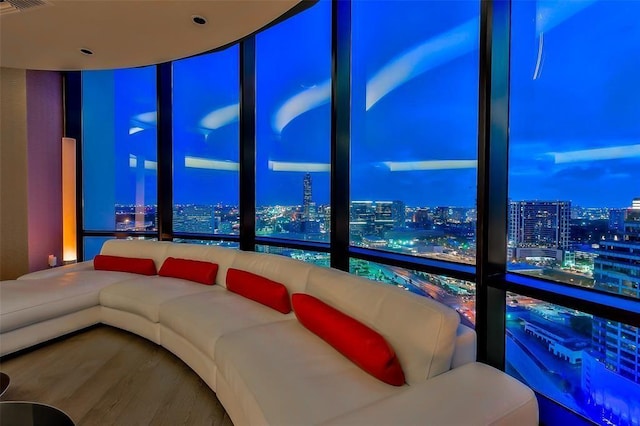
[160, 286, 295, 359]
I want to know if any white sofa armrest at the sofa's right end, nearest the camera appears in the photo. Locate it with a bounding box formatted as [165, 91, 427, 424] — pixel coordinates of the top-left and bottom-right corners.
[324, 362, 538, 426]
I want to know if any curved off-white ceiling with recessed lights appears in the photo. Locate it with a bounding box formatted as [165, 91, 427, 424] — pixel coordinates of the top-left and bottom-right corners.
[0, 0, 314, 70]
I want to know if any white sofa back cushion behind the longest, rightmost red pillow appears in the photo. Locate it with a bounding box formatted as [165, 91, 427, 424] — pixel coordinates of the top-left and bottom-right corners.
[306, 268, 460, 384]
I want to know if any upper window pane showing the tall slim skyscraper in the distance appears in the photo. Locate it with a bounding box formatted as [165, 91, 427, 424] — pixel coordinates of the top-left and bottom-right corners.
[256, 0, 331, 241]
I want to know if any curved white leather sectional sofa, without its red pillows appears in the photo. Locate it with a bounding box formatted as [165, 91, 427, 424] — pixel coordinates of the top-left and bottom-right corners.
[0, 240, 538, 426]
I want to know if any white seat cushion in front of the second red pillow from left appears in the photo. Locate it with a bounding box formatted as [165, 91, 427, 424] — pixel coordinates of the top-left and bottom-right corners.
[100, 276, 215, 322]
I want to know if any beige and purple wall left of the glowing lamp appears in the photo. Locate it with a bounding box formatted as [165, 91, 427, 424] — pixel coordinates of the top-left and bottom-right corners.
[0, 68, 62, 280]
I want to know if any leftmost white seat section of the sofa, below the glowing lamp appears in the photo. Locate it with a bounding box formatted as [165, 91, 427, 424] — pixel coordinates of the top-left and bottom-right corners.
[0, 270, 139, 333]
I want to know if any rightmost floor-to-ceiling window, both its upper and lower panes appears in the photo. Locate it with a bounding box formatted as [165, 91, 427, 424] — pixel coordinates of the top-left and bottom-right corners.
[507, 1, 640, 424]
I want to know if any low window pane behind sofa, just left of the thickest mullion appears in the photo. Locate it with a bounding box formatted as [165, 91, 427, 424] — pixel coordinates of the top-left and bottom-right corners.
[349, 258, 476, 328]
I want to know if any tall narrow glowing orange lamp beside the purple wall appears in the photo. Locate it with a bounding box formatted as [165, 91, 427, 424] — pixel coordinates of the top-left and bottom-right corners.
[62, 138, 78, 264]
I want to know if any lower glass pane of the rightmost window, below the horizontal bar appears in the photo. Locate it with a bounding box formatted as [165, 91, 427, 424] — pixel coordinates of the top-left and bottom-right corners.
[506, 293, 640, 425]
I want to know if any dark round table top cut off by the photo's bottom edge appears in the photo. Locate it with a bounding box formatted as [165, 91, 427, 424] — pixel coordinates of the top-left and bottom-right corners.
[0, 401, 75, 426]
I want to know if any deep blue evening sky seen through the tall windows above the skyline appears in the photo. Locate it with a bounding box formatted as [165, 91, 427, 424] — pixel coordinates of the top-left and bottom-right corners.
[84, 0, 640, 211]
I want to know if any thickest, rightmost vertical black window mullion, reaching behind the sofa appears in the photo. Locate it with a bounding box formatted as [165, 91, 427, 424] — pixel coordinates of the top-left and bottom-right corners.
[476, 0, 511, 368]
